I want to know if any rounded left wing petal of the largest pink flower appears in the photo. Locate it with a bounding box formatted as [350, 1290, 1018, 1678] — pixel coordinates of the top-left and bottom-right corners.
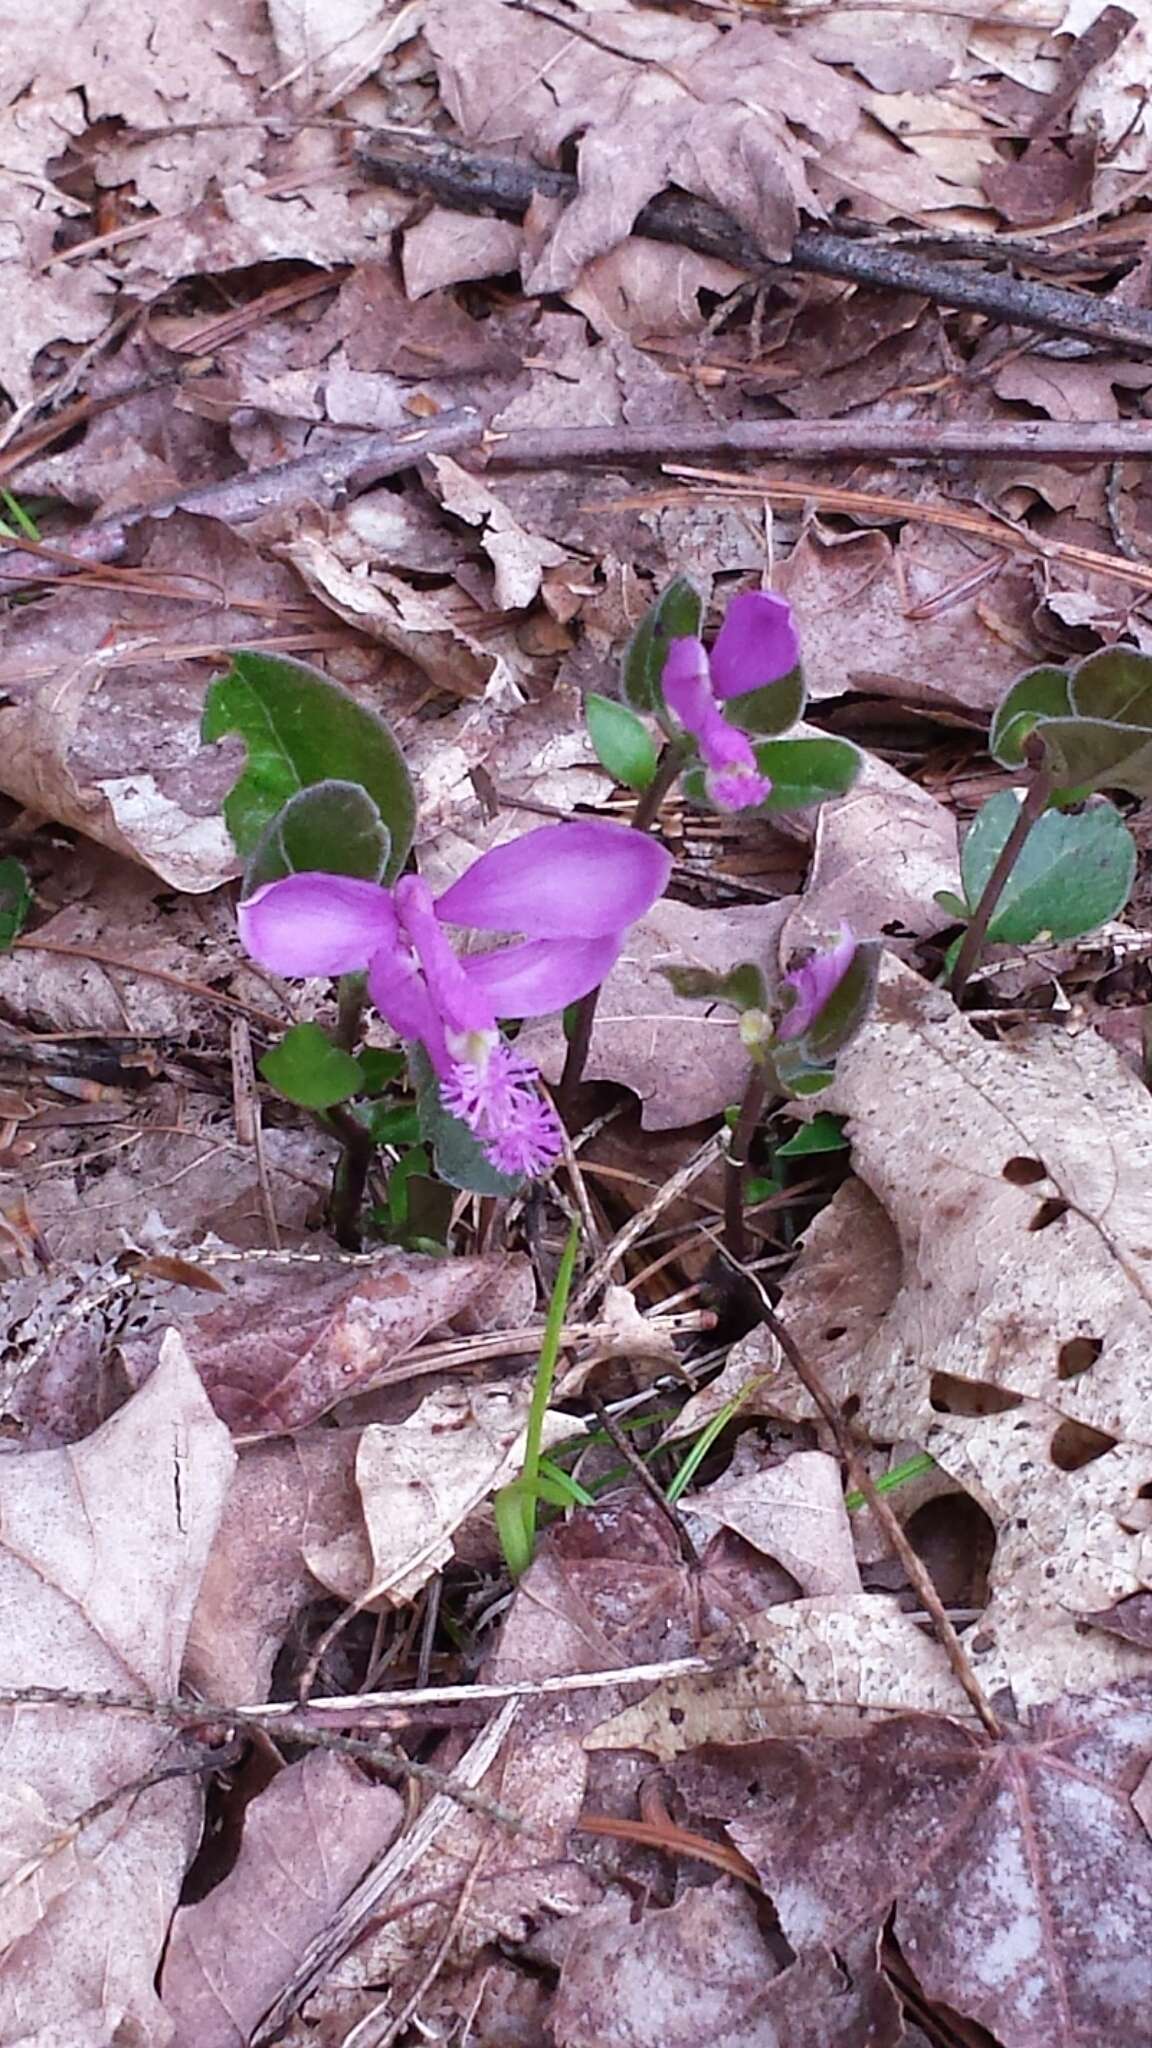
[236, 872, 396, 975]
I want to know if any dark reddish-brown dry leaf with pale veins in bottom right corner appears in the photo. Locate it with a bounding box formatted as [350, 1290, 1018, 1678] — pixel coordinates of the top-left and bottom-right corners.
[674, 1686, 1152, 2048]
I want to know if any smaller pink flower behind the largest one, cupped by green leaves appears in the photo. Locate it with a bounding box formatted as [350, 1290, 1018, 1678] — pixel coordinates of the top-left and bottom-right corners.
[660, 590, 799, 811]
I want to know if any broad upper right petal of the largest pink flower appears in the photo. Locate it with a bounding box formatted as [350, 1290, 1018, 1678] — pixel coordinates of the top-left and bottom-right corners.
[437, 819, 672, 937]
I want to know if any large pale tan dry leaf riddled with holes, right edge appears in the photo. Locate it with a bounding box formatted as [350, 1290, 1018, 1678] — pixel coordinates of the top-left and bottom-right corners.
[725, 958, 1152, 1704]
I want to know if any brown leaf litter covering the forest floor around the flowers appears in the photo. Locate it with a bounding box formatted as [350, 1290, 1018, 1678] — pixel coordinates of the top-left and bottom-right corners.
[0, 0, 1152, 2048]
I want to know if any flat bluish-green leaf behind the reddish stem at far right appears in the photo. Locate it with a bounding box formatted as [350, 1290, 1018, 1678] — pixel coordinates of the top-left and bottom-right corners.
[959, 788, 1136, 946]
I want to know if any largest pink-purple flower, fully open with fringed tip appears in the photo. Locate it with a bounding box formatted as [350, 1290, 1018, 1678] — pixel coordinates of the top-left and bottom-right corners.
[238, 821, 672, 1176]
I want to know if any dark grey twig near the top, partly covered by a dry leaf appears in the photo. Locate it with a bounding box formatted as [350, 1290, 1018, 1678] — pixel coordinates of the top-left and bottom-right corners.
[361, 137, 1152, 356]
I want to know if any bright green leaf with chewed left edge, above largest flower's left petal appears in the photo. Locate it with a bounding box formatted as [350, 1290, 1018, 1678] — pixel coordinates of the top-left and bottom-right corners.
[201, 649, 416, 881]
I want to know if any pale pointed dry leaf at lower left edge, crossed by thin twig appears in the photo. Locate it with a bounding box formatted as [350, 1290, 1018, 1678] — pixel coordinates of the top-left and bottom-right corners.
[0, 1331, 234, 2048]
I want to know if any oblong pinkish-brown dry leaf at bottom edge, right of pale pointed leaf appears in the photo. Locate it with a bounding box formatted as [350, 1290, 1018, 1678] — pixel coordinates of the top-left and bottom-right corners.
[160, 1749, 404, 2048]
